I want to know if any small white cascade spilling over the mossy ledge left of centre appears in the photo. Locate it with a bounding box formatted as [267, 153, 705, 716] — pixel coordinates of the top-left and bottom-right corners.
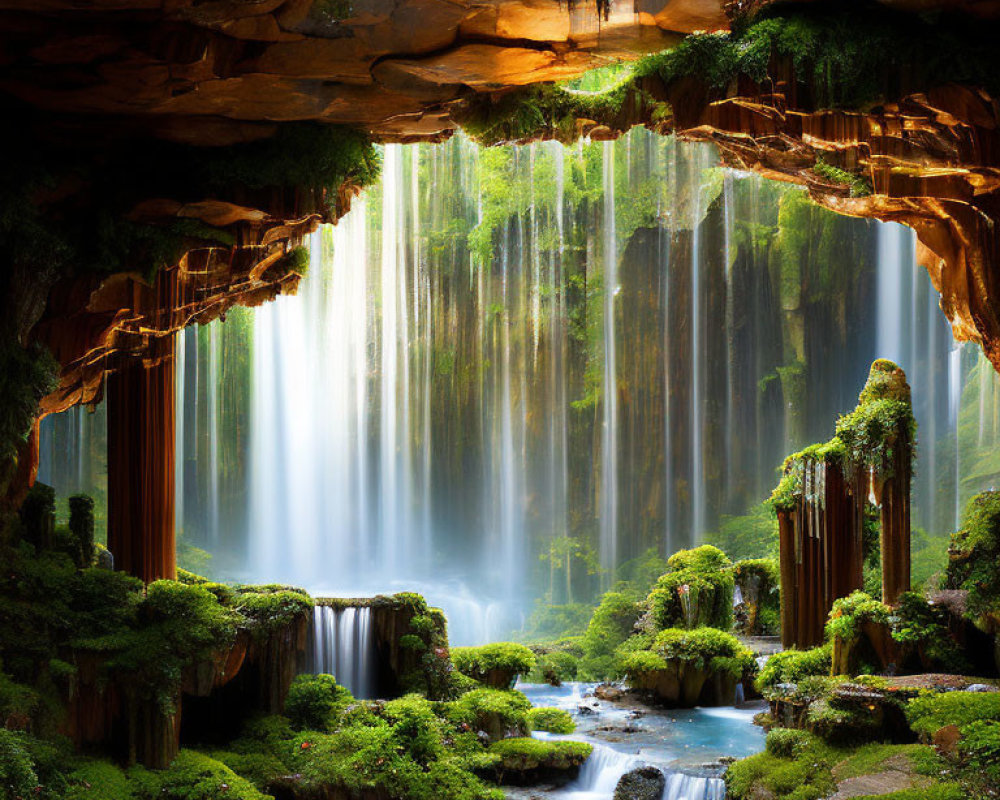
[309, 605, 375, 700]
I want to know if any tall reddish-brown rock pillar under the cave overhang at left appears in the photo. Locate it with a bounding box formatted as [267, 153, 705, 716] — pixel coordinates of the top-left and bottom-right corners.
[105, 336, 177, 583]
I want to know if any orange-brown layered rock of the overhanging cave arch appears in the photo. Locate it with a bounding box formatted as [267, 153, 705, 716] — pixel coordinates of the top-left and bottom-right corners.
[0, 0, 1000, 512]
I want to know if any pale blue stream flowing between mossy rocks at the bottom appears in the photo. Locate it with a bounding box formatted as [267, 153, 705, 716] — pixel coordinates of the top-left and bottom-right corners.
[513, 682, 764, 800]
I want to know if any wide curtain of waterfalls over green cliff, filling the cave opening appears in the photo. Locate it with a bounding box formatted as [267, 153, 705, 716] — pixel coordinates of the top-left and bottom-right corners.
[29, 130, 984, 643]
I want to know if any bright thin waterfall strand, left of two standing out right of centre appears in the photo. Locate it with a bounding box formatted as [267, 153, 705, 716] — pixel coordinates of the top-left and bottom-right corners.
[600, 142, 618, 584]
